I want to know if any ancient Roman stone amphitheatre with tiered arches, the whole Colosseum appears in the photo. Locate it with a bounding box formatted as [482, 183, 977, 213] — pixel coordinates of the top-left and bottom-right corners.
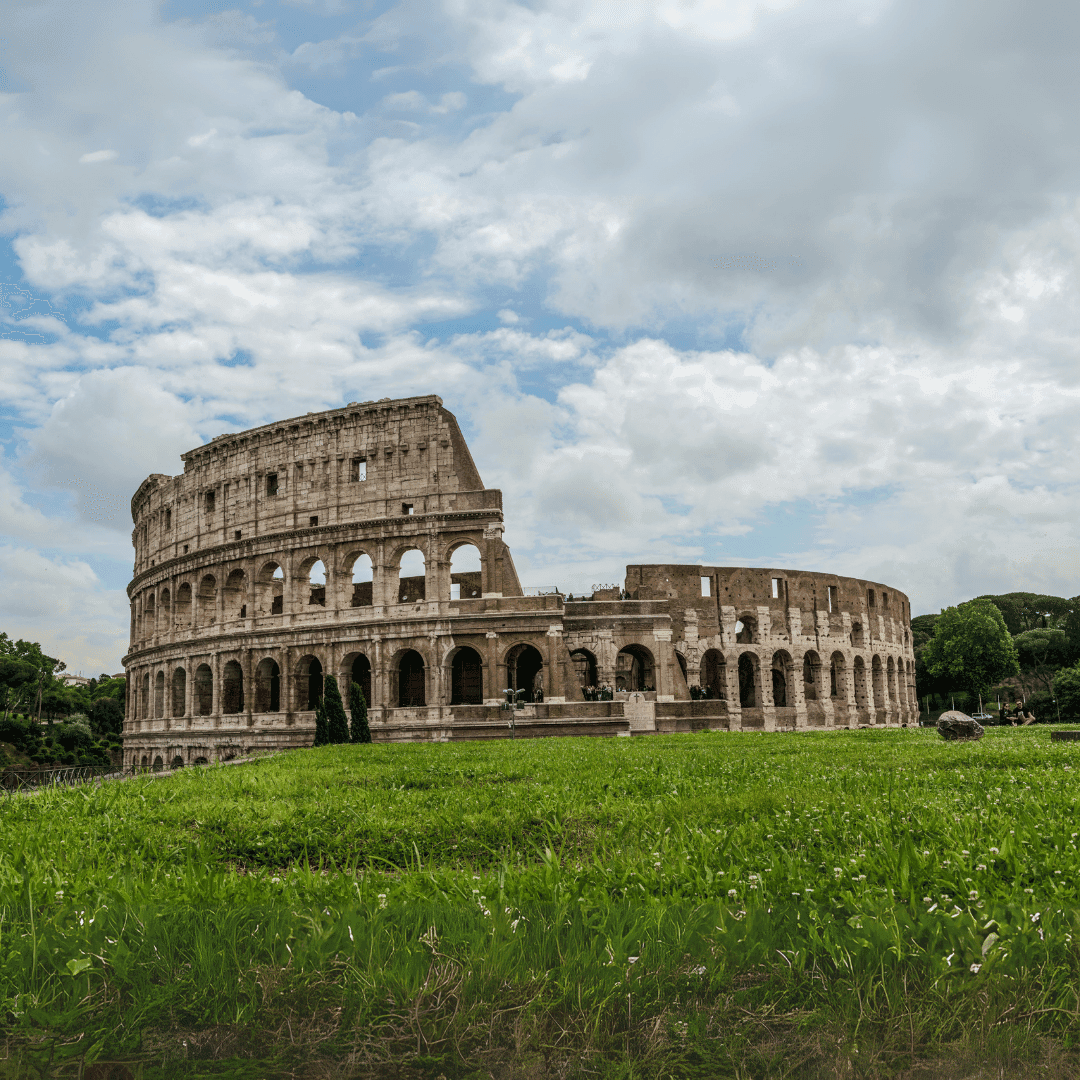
[124, 395, 917, 767]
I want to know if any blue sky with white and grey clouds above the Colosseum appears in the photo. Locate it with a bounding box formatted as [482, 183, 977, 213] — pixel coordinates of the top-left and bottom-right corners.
[0, 0, 1080, 674]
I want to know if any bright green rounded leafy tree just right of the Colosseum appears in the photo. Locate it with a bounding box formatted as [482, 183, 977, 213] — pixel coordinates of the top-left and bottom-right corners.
[923, 599, 1020, 693]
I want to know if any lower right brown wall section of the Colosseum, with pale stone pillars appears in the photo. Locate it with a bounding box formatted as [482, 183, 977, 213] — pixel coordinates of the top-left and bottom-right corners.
[625, 564, 918, 727]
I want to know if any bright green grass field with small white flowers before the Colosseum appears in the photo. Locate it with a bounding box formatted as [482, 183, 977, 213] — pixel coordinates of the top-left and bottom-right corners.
[0, 728, 1080, 1080]
